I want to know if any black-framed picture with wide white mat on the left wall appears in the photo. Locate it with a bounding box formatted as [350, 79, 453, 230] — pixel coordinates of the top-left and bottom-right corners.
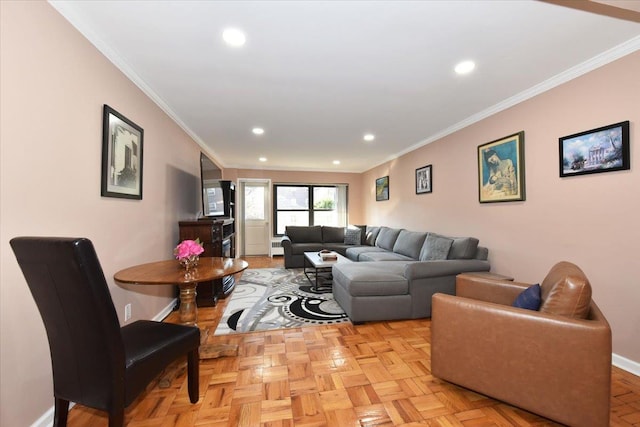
[100, 104, 144, 200]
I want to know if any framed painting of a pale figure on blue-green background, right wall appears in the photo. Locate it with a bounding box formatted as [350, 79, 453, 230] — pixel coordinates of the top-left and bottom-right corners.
[478, 131, 525, 203]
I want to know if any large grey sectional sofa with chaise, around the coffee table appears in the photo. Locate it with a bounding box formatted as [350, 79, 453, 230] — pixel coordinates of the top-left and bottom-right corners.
[282, 226, 490, 323]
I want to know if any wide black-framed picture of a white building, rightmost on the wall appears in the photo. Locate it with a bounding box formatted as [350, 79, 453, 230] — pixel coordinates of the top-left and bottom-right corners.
[559, 121, 630, 177]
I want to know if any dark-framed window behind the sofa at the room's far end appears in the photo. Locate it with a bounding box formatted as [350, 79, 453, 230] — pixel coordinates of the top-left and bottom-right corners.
[273, 184, 347, 235]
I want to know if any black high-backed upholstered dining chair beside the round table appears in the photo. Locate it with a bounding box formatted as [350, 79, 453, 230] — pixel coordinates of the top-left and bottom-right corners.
[11, 237, 200, 427]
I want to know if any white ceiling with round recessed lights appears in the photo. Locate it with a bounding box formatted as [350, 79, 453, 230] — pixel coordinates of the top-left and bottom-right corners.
[51, 0, 640, 172]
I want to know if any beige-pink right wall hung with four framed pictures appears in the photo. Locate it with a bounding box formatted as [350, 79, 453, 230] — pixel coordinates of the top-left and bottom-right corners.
[363, 52, 640, 364]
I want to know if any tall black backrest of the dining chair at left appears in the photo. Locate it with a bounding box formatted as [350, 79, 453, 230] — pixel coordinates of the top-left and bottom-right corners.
[10, 237, 125, 410]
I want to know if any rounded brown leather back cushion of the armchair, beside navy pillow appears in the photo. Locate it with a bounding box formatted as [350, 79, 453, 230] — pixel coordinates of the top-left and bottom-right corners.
[540, 267, 591, 319]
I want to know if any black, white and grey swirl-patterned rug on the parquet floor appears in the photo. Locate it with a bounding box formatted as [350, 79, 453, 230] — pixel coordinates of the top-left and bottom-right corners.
[214, 268, 349, 335]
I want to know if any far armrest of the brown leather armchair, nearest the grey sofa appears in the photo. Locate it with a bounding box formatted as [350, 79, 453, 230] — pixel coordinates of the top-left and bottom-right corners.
[456, 274, 531, 305]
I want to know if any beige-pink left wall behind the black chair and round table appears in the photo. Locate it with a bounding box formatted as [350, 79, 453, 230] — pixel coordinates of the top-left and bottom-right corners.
[0, 1, 200, 426]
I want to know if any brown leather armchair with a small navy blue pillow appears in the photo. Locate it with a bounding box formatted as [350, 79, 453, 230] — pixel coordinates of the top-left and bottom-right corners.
[431, 262, 611, 427]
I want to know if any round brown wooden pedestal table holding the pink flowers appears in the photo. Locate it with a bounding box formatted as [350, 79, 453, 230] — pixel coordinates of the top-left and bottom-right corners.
[113, 257, 249, 359]
